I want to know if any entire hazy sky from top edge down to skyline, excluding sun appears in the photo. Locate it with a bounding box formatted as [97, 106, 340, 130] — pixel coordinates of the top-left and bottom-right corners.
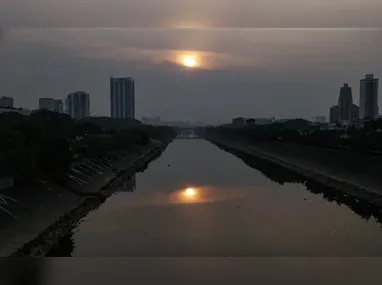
[0, 0, 382, 122]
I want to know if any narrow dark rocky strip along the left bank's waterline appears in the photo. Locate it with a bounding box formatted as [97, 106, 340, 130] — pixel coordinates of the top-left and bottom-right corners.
[10, 141, 172, 257]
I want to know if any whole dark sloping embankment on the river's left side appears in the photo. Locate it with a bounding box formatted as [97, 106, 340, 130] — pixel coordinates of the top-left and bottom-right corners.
[0, 139, 172, 256]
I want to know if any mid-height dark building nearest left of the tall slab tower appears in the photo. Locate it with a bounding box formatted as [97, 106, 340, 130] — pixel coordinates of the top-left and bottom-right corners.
[65, 91, 90, 119]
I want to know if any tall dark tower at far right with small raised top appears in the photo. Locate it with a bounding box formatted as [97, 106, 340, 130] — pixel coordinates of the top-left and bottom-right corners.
[359, 74, 378, 119]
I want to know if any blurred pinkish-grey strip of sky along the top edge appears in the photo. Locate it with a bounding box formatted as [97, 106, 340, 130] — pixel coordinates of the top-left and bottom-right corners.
[0, 0, 382, 28]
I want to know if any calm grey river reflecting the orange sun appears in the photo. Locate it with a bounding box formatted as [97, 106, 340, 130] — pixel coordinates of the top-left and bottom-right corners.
[48, 139, 382, 257]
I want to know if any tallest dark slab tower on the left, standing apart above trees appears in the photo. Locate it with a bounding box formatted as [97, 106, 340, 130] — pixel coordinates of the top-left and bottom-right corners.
[110, 77, 135, 119]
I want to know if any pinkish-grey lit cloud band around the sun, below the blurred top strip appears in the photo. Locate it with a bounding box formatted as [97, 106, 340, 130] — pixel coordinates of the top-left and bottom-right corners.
[8, 29, 382, 70]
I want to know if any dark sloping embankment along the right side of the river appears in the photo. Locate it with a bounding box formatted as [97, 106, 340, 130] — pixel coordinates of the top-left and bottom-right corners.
[207, 137, 382, 207]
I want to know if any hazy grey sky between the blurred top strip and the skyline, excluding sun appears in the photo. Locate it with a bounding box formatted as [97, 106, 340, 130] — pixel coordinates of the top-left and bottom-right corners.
[0, 25, 382, 121]
